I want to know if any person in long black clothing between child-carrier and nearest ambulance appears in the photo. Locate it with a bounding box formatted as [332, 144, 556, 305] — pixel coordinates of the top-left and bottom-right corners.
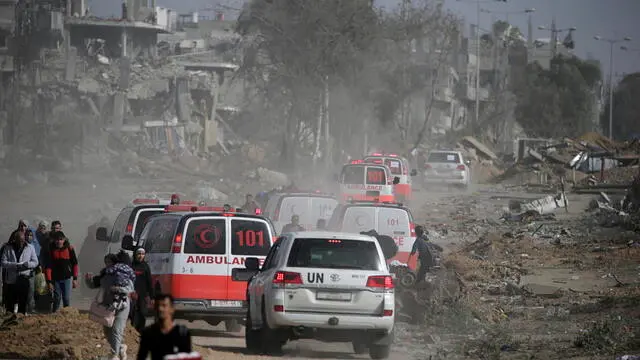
[130, 248, 154, 333]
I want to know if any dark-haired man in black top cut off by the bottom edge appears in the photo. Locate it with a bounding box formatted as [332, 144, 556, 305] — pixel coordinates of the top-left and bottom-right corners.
[137, 294, 192, 360]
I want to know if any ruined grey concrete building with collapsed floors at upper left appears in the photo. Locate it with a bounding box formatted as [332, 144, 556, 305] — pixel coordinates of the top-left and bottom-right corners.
[0, 0, 244, 174]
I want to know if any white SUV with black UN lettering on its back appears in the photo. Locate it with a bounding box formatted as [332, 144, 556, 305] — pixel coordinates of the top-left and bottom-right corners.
[237, 231, 395, 359]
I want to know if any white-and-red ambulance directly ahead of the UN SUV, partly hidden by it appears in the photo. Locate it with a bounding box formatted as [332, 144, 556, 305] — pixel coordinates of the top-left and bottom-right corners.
[328, 201, 417, 269]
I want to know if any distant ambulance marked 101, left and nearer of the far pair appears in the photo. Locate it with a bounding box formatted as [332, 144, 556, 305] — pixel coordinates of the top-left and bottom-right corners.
[338, 160, 400, 202]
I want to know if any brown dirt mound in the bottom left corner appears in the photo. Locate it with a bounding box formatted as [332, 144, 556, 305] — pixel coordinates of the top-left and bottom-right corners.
[0, 307, 218, 360]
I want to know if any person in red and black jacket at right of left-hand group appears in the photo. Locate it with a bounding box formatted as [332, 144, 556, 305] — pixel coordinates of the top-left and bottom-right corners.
[45, 231, 78, 312]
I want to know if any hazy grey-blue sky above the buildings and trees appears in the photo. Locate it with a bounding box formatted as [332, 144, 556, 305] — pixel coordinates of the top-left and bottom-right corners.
[87, 0, 640, 82]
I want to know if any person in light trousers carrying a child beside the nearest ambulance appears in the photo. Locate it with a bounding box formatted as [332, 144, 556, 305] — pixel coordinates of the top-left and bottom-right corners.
[85, 251, 135, 360]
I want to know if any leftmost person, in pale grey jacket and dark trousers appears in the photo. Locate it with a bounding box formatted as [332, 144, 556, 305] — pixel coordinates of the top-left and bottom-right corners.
[0, 232, 38, 314]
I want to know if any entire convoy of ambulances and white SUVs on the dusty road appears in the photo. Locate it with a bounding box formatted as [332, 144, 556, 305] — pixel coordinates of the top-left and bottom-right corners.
[91, 151, 460, 359]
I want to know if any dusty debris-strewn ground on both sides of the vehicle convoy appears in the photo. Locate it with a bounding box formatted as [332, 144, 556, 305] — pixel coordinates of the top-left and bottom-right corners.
[0, 172, 640, 360]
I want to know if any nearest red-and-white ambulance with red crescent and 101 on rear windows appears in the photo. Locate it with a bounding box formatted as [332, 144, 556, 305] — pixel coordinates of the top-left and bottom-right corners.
[138, 205, 275, 331]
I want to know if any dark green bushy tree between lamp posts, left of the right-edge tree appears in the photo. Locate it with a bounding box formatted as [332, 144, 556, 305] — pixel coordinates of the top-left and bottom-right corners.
[515, 56, 602, 138]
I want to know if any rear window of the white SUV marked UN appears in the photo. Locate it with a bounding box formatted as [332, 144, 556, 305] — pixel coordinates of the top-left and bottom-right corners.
[287, 239, 381, 270]
